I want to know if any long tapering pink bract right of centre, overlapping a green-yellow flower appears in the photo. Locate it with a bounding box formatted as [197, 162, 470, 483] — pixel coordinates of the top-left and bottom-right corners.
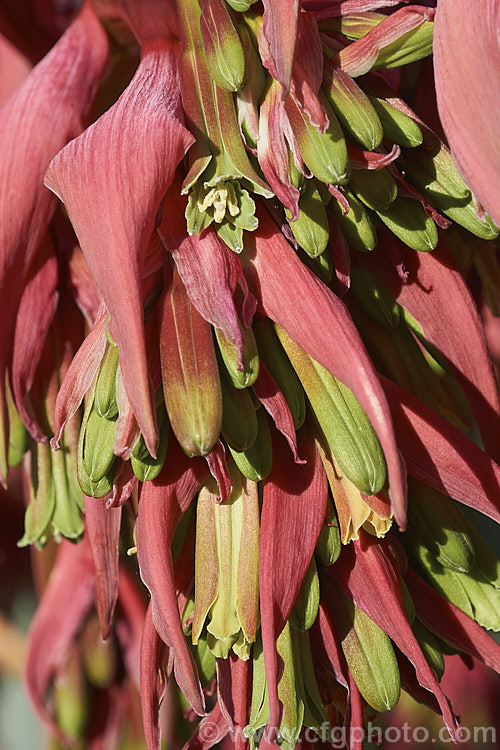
[245, 210, 406, 528]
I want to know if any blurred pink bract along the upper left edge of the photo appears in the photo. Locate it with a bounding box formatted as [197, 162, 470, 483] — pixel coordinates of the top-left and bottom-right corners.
[0, 0, 108, 481]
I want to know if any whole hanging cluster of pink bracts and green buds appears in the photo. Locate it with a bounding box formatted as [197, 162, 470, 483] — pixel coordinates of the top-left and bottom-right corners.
[0, 0, 500, 750]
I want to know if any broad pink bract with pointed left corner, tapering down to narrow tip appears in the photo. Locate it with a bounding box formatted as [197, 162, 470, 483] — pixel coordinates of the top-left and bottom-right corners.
[45, 41, 193, 462]
